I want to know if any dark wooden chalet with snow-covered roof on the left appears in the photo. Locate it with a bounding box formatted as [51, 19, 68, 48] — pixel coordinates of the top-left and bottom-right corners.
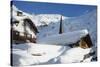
[11, 18, 38, 43]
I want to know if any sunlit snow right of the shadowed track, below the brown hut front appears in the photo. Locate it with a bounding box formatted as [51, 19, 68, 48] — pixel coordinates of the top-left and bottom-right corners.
[61, 47, 91, 63]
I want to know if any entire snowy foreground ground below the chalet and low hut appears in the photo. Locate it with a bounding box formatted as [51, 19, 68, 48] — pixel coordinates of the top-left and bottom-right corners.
[12, 43, 92, 65]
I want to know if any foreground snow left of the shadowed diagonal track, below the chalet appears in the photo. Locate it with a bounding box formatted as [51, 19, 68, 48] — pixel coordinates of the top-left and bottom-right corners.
[12, 43, 70, 66]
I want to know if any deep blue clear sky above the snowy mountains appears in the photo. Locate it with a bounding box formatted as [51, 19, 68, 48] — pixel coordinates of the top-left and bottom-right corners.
[13, 0, 97, 17]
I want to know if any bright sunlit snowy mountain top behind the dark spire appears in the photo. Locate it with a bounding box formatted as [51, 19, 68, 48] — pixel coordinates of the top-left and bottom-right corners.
[36, 14, 67, 24]
